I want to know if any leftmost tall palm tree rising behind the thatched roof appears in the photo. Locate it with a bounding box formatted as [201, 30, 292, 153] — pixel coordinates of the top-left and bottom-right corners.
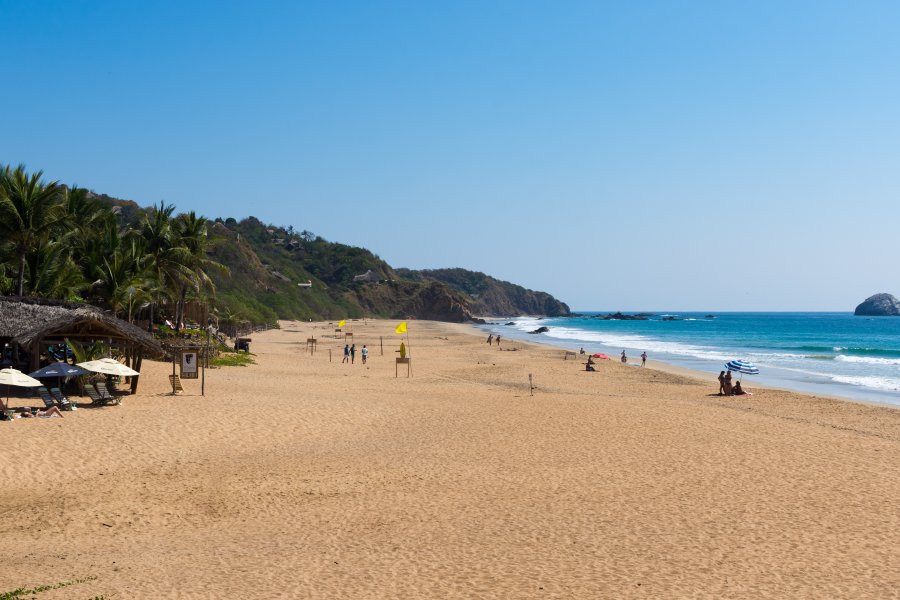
[0, 165, 64, 296]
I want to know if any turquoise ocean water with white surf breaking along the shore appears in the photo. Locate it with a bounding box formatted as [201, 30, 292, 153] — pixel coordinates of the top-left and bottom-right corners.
[483, 312, 900, 406]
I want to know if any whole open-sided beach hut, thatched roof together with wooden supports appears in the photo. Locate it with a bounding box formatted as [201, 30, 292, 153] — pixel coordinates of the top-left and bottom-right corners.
[0, 296, 165, 393]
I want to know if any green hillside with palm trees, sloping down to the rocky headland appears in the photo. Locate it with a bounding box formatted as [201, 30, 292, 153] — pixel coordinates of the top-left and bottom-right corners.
[0, 166, 568, 327]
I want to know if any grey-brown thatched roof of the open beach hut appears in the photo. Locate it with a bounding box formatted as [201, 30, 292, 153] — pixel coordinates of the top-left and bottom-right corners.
[0, 296, 164, 356]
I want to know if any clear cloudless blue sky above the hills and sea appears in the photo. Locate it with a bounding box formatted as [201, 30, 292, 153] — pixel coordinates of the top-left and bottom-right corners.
[0, 0, 900, 311]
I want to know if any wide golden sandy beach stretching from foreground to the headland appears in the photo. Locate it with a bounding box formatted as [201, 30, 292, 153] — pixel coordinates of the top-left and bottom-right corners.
[0, 321, 900, 599]
